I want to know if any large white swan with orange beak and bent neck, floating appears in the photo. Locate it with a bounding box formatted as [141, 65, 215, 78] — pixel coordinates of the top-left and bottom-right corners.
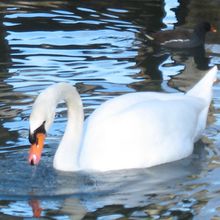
[29, 67, 217, 171]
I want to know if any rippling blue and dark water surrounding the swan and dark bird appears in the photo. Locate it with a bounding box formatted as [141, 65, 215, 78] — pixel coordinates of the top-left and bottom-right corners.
[0, 0, 220, 220]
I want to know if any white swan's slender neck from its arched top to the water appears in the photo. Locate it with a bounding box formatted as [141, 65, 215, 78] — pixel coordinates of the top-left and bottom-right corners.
[53, 84, 84, 171]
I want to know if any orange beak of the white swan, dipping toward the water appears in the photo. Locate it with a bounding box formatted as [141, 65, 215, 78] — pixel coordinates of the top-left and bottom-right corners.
[28, 133, 46, 165]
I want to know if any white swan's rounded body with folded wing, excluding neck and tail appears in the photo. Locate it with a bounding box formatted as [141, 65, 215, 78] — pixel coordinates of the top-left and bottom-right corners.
[80, 93, 205, 171]
